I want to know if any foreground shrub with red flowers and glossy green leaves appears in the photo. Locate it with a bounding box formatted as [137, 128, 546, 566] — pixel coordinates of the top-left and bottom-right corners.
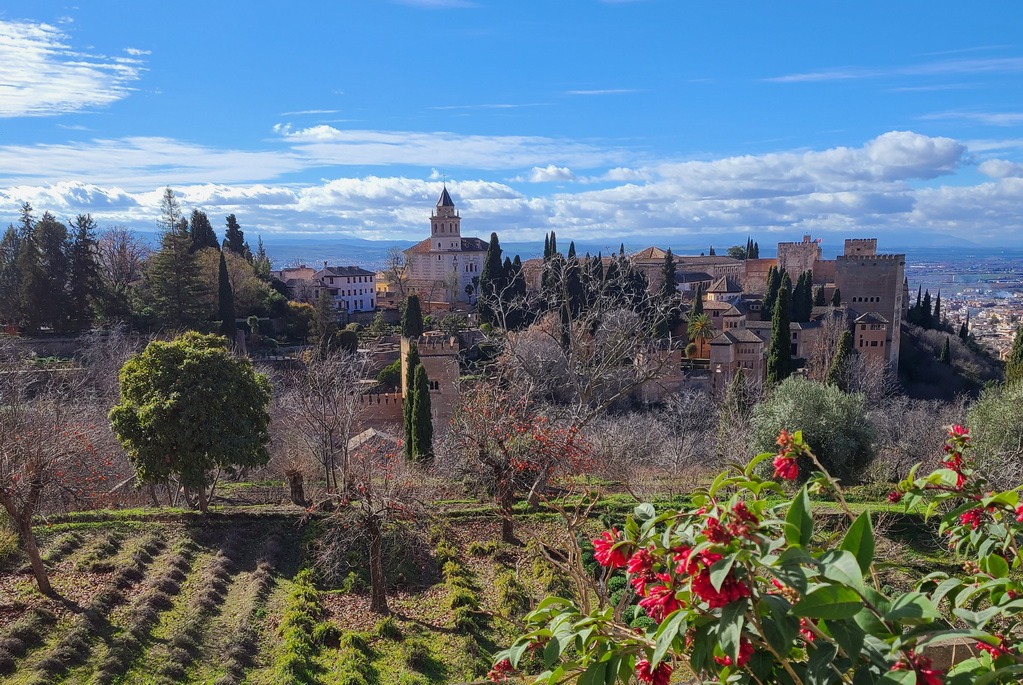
[491, 426, 1023, 685]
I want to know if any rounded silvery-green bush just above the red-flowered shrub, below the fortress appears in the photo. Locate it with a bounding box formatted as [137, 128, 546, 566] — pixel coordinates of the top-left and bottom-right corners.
[753, 376, 874, 483]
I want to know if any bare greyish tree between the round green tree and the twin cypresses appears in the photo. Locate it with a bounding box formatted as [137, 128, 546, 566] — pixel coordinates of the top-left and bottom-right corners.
[281, 350, 366, 493]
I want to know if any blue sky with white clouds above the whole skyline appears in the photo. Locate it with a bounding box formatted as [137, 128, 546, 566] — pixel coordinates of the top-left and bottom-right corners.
[0, 0, 1023, 252]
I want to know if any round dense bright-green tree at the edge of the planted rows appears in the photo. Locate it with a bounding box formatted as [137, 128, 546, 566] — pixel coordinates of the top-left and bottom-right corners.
[109, 331, 270, 512]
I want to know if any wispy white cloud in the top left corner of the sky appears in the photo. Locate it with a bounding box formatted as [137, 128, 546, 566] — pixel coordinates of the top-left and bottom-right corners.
[0, 19, 142, 118]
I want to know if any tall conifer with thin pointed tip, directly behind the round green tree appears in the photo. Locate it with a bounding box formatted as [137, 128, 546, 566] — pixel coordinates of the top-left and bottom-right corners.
[145, 200, 209, 328]
